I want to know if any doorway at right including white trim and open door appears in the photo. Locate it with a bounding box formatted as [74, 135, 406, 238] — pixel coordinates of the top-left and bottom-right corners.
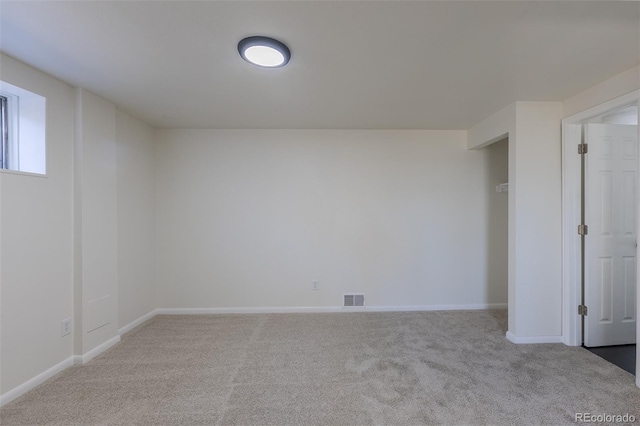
[562, 90, 640, 380]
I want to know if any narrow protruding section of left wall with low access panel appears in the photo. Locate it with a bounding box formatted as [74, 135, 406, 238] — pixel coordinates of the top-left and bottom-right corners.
[75, 89, 118, 354]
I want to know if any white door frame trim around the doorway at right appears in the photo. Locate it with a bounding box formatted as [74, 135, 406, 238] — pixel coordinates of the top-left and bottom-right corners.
[562, 90, 640, 348]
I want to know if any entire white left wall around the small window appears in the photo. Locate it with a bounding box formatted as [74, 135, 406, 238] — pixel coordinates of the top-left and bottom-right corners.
[0, 54, 155, 404]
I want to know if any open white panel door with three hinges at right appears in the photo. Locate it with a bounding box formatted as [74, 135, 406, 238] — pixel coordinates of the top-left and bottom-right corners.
[584, 124, 638, 347]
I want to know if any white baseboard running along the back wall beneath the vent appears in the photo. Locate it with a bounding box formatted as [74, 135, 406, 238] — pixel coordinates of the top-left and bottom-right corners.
[154, 303, 507, 315]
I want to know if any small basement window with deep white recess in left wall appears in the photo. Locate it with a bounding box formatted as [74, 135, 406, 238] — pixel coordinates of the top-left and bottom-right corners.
[0, 81, 47, 175]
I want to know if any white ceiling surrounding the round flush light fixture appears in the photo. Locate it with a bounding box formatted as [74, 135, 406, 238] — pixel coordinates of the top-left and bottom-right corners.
[0, 1, 640, 129]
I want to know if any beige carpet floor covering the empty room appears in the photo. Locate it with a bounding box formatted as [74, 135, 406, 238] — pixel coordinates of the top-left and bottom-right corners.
[0, 311, 640, 426]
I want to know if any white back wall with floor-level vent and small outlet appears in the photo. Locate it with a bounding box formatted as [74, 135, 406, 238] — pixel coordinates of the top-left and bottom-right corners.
[156, 130, 505, 308]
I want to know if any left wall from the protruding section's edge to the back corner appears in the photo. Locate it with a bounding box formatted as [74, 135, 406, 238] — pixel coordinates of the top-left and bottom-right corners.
[75, 89, 155, 346]
